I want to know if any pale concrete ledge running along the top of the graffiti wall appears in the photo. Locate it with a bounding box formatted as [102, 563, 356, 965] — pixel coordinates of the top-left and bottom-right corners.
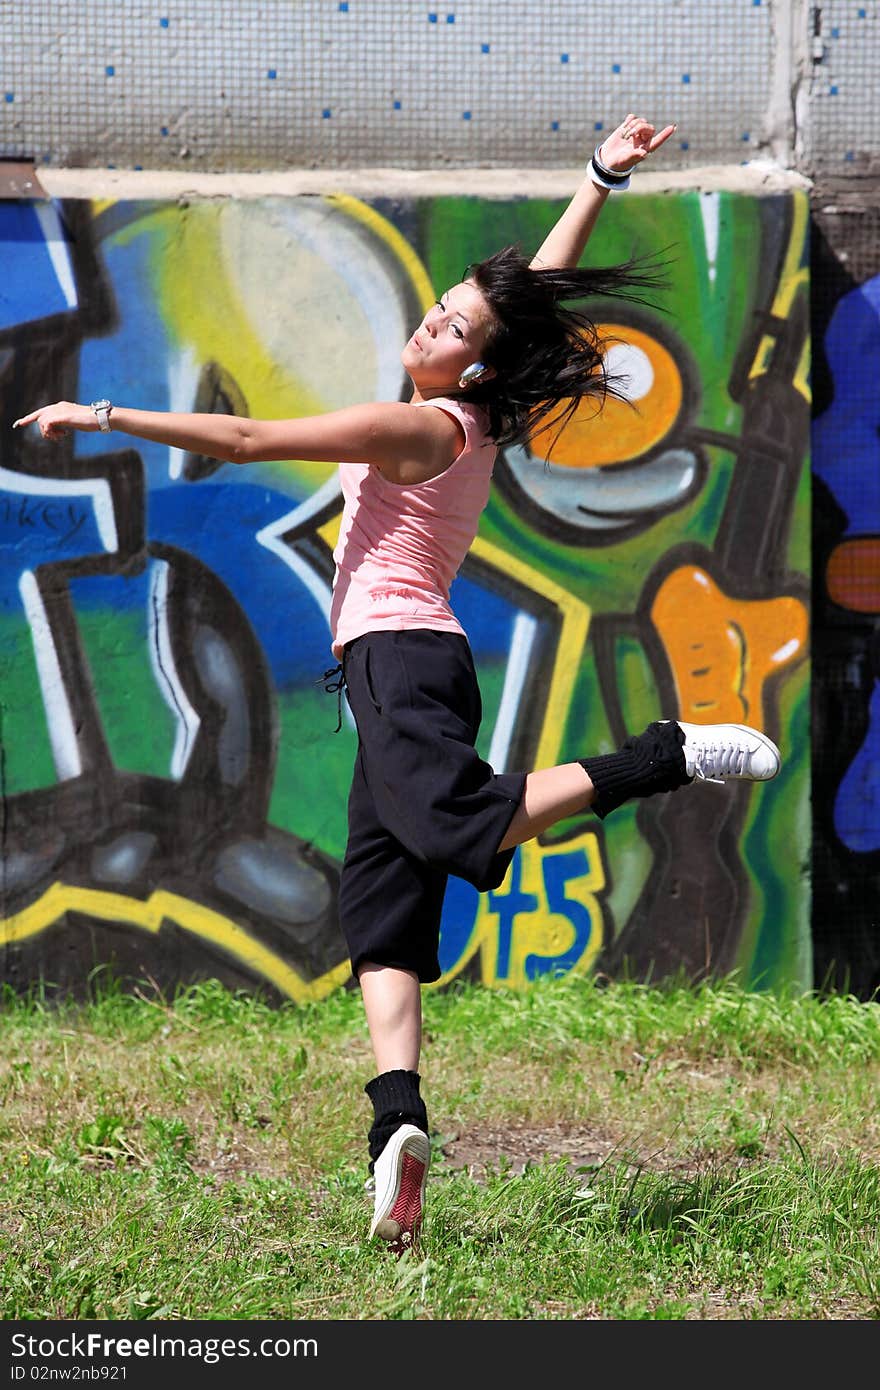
[36, 160, 812, 199]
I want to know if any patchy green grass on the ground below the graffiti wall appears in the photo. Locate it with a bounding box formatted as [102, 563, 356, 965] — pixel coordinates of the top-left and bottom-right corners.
[0, 977, 880, 1321]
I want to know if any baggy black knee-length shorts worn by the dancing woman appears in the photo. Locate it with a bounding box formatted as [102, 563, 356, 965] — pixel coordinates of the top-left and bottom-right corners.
[339, 628, 525, 984]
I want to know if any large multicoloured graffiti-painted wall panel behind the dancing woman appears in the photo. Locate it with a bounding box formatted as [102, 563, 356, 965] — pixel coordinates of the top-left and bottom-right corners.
[0, 192, 811, 1001]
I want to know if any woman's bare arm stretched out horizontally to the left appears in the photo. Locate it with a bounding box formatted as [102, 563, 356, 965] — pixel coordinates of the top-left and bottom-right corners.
[13, 400, 460, 482]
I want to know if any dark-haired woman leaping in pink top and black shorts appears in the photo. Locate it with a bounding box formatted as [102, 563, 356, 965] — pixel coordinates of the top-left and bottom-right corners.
[15, 114, 780, 1252]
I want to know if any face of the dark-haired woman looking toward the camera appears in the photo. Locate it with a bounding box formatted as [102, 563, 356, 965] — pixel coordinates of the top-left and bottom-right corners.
[400, 279, 492, 396]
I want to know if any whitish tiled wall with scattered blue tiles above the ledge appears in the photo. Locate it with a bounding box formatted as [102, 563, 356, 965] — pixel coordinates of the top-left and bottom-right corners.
[0, 0, 880, 172]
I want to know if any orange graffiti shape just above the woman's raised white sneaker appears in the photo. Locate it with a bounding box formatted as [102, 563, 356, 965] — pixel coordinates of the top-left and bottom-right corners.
[651, 566, 808, 728]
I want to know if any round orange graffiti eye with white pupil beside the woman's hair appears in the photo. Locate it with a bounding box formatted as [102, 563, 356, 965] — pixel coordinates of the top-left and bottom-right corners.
[531, 324, 684, 468]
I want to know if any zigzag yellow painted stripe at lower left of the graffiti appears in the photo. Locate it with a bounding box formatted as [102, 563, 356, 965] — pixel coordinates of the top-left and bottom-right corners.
[0, 883, 352, 1004]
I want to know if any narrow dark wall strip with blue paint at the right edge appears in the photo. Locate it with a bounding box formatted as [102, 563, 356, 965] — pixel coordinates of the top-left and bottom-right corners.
[812, 199, 880, 998]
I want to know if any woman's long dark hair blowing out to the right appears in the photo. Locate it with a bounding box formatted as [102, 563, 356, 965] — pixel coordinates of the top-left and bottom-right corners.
[463, 246, 665, 453]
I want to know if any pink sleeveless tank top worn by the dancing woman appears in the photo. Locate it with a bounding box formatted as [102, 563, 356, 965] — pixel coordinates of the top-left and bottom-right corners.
[329, 396, 498, 660]
